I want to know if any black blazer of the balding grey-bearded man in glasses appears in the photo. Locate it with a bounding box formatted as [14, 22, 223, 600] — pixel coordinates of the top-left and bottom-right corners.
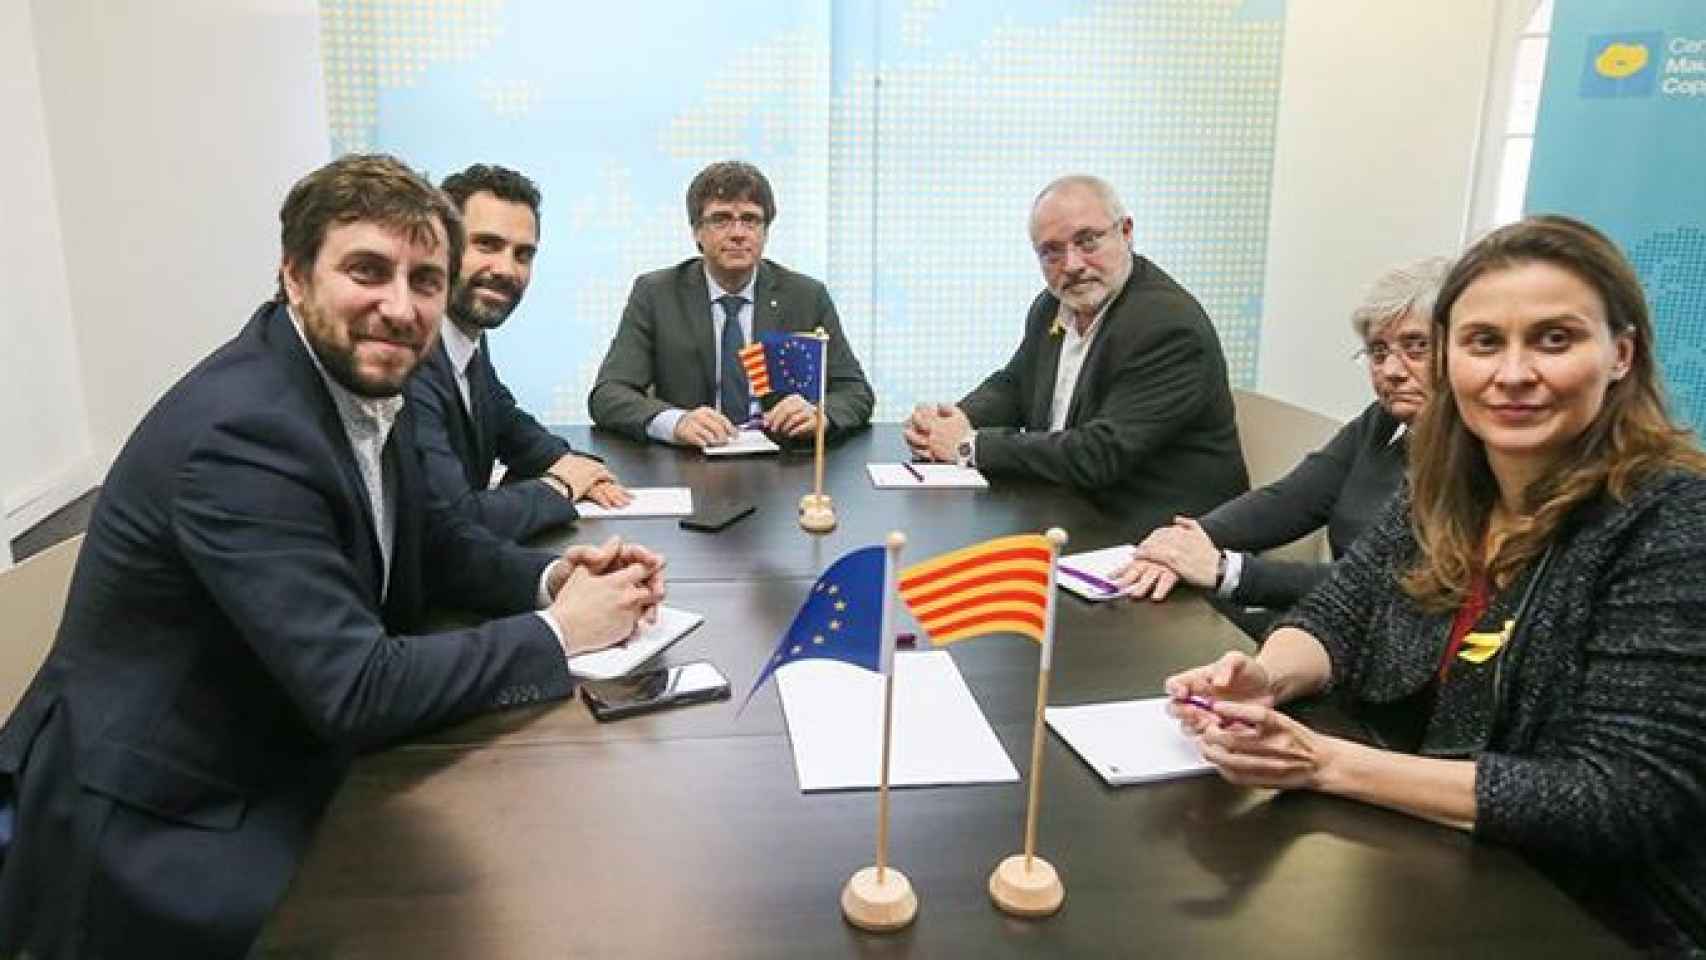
[959, 256, 1250, 539]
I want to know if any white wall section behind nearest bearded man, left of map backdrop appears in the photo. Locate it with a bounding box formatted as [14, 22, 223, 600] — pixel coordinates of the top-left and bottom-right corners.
[28, 0, 329, 472]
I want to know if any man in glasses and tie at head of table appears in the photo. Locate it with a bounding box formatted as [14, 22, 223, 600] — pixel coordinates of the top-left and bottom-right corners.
[587, 162, 875, 447]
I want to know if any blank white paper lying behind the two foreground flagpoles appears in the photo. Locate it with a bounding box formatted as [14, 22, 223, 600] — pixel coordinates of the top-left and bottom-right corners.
[776, 650, 1018, 793]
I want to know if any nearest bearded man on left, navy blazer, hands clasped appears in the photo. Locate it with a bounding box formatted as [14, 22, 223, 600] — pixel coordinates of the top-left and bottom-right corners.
[0, 157, 664, 958]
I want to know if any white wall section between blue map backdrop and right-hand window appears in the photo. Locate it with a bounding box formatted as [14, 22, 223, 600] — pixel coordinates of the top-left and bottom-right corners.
[1257, 0, 1517, 418]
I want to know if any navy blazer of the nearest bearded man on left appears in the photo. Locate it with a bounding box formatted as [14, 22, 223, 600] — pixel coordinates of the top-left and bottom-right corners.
[0, 304, 570, 958]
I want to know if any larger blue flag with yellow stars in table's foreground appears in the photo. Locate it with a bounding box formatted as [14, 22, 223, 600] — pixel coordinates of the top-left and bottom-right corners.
[740, 547, 884, 709]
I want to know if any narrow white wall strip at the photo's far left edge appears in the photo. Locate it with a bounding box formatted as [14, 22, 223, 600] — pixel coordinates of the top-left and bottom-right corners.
[0, 0, 92, 568]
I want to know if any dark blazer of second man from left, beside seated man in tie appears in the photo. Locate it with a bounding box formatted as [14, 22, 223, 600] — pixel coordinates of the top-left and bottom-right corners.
[408, 336, 578, 541]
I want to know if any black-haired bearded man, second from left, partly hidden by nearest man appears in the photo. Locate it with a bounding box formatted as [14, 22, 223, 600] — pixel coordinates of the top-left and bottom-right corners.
[408, 164, 633, 541]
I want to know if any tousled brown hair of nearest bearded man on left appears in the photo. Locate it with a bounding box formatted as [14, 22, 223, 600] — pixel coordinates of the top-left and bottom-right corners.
[273, 153, 466, 304]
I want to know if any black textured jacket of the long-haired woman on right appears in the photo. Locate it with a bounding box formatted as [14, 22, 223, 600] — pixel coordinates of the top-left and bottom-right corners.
[1280, 472, 1706, 957]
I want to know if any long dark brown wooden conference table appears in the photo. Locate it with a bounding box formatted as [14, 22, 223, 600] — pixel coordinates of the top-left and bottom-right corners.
[256, 425, 1631, 958]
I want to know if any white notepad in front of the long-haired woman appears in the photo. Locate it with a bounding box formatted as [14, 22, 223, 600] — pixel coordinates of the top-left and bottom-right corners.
[1042, 697, 1215, 786]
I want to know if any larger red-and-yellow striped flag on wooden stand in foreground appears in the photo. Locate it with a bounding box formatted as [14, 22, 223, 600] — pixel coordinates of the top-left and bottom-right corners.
[897, 534, 1053, 646]
